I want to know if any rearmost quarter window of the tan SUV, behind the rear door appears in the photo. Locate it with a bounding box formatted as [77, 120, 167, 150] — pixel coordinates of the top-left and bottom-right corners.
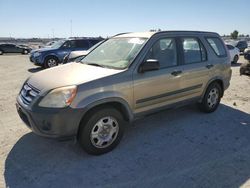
[207, 37, 227, 57]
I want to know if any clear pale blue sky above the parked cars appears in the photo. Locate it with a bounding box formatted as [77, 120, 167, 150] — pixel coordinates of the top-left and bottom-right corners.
[0, 0, 250, 38]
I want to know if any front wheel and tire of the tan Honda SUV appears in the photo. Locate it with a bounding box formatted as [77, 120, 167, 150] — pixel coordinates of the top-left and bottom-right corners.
[78, 106, 125, 155]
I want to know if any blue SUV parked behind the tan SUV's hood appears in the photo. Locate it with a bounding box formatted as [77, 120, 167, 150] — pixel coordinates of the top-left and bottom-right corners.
[30, 37, 103, 68]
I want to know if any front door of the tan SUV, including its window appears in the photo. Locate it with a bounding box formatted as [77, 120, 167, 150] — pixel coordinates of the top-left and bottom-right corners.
[133, 38, 182, 113]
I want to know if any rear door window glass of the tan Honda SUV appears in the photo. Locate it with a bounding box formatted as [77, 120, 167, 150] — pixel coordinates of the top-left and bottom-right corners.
[182, 38, 207, 64]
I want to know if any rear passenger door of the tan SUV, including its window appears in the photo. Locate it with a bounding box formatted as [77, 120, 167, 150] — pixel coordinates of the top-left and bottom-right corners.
[179, 36, 210, 100]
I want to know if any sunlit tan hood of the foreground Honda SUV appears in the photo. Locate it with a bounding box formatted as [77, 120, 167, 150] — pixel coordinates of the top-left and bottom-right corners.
[28, 63, 124, 94]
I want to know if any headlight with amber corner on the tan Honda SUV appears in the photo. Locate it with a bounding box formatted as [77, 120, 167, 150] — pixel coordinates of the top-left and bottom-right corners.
[39, 86, 77, 108]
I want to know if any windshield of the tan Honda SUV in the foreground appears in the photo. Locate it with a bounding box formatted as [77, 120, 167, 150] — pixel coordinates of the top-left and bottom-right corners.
[81, 38, 146, 69]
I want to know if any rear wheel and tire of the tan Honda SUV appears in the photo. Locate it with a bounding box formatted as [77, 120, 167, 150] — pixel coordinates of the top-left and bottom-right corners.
[198, 82, 222, 113]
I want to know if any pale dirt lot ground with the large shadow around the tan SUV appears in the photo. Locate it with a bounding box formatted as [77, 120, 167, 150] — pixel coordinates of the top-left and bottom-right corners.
[0, 55, 250, 188]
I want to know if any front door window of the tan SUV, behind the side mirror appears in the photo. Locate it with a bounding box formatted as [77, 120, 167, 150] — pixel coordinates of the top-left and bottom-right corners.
[146, 38, 177, 68]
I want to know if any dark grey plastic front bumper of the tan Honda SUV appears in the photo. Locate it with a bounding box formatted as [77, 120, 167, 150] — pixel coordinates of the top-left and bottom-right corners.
[16, 96, 83, 138]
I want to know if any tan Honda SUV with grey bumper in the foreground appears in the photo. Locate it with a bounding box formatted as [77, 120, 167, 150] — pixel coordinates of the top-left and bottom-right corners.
[16, 31, 231, 155]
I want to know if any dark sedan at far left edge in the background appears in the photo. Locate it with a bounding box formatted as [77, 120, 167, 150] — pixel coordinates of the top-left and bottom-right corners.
[0, 43, 32, 55]
